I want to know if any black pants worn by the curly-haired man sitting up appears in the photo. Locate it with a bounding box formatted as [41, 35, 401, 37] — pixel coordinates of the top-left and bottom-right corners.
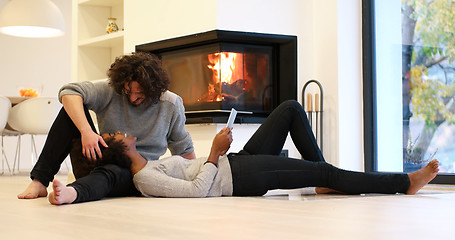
[30, 108, 140, 202]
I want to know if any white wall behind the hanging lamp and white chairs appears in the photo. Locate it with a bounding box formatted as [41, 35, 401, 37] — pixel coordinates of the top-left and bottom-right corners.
[0, 0, 71, 169]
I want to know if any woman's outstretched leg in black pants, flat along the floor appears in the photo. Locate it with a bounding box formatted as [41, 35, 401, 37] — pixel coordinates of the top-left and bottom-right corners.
[229, 155, 410, 196]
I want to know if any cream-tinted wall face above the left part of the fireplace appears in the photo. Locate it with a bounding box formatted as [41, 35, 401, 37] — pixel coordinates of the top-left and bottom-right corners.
[124, 0, 216, 53]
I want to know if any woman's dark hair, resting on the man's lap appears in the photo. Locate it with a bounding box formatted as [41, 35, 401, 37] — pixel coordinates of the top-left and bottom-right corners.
[70, 137, 131, 179]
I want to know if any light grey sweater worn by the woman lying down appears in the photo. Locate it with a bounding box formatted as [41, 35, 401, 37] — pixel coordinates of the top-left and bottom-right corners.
[133, 155, 233, 197]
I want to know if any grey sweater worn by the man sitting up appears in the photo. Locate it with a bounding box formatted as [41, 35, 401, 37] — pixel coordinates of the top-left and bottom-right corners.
[59, 80, 194, 160]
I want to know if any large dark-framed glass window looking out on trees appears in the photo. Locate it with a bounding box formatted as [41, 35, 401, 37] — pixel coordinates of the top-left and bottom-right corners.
[363, 0, 455, 183]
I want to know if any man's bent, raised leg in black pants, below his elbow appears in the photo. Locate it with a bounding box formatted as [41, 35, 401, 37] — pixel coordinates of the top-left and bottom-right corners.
[30, 108, 96, 187]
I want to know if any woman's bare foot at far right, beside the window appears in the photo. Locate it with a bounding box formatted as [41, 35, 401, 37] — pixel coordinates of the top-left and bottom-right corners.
[406, 159, 439, 194]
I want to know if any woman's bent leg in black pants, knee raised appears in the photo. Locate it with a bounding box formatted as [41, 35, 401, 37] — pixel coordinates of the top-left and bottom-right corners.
[241, 100, 325, 162]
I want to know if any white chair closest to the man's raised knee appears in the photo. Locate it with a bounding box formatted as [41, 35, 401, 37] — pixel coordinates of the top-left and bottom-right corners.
[8, 97, 62, 172]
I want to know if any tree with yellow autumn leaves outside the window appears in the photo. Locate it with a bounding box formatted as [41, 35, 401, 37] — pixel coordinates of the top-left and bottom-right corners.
[404, 0, 455, 173]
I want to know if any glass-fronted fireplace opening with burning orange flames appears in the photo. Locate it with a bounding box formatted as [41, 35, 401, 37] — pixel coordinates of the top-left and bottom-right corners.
[161, 44, 273, 113]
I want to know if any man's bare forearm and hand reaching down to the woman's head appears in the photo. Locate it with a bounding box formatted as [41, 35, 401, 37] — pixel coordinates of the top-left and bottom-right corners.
[62, 95, 107, 160]
